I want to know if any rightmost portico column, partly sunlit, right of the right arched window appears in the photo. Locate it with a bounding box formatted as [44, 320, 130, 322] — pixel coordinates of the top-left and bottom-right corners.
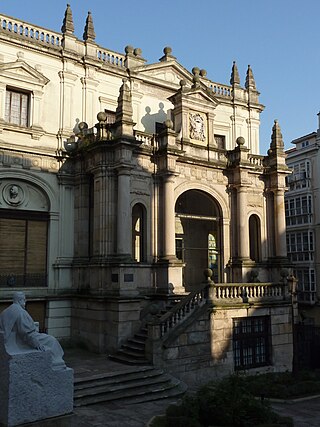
[274, 189, 287, 257]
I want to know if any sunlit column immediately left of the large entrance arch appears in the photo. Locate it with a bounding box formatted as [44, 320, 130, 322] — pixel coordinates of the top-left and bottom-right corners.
[163, 174, 176, 260]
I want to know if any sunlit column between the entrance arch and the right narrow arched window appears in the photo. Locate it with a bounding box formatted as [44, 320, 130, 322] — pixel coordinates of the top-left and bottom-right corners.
[237, 187, 249, 258]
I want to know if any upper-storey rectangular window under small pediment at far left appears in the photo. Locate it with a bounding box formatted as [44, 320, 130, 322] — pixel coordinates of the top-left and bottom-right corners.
[5, 89, 30, 127]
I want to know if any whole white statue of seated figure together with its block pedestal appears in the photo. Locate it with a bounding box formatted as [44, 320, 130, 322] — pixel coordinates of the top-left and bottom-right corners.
[0, 292, 73, 427]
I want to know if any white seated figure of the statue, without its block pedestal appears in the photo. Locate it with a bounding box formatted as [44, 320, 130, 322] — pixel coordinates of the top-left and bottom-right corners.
[0, 292, 65, 368]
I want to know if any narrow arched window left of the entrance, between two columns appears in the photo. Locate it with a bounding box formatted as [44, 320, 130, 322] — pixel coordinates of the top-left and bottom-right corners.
[132, 203, 146, 262]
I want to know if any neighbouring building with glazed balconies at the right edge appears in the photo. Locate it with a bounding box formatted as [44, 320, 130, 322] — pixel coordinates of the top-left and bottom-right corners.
[285, 115, 320, 324]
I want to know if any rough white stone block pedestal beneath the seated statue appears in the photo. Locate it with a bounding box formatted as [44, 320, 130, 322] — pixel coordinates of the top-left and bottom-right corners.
[0, 332, 73, 427]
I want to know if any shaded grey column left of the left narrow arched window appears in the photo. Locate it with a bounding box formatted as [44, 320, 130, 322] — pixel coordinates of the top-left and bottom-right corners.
[117, 167, 132, 256]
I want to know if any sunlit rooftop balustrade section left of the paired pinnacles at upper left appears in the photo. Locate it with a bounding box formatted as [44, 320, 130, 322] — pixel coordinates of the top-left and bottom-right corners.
[0, 15, 62, 48]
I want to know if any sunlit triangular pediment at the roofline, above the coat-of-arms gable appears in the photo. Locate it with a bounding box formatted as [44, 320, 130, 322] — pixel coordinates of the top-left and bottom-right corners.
[135, 60, 192, 85]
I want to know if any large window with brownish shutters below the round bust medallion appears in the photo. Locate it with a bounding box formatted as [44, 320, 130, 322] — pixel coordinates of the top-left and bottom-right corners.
[0, 214, 48, 287]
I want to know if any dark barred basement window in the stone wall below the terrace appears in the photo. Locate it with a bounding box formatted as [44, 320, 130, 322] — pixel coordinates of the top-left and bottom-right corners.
[233, 316, 271, 369]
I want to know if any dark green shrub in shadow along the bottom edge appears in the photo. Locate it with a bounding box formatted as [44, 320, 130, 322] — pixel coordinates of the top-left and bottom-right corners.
[159, 374, 294, 427]
